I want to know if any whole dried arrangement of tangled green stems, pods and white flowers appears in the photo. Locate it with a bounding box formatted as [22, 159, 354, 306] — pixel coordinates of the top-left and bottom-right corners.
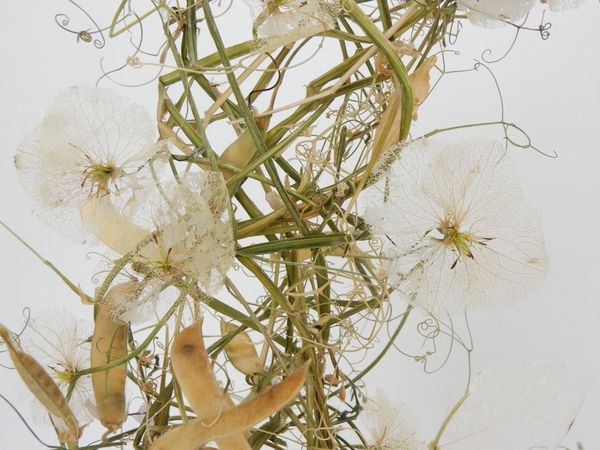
[0, 0, 591, 450]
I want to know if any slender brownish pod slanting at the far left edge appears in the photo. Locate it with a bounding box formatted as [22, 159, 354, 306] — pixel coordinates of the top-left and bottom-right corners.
[0, 325, 81, 443]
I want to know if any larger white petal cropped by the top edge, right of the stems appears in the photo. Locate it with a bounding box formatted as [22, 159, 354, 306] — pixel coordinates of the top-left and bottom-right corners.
[457, 0, 536, 28]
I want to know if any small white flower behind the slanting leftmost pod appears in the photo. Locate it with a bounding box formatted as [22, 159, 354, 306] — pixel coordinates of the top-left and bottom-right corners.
[21, 308, 94, 424]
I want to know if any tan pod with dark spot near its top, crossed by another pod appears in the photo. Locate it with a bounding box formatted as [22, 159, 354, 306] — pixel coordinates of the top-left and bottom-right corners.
[171, 320, 250, 450]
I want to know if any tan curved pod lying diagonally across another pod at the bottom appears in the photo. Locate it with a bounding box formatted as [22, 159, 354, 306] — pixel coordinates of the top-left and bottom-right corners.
[149, 362, 310, 450]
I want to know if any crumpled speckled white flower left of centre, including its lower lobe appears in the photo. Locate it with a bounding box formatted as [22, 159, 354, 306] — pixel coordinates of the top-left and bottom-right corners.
[101, 172, 235, 322]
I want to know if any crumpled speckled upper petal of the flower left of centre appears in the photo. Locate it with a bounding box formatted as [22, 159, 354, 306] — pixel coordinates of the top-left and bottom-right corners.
[137, 172, 235, 292]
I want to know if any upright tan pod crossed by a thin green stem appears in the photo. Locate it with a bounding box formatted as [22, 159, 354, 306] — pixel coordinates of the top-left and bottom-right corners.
[90, 281, 138, 432]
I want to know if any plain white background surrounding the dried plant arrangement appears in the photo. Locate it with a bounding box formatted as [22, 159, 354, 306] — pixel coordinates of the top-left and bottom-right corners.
[0, 0, 600, 450]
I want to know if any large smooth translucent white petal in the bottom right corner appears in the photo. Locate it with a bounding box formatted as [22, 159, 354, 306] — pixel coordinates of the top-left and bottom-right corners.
[440, 361, 593, 450]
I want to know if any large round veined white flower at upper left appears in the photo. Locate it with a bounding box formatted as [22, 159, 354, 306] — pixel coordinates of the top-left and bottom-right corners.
[15, 85, 166, 244]
